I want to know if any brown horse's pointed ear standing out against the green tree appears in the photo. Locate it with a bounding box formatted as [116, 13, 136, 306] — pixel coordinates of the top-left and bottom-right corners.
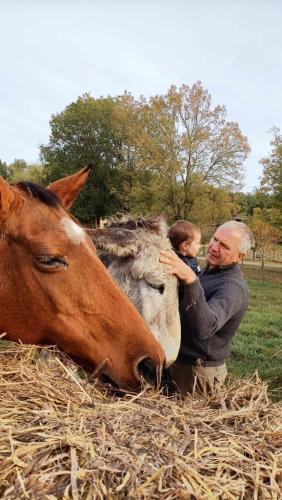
[48, 165, 92, 208]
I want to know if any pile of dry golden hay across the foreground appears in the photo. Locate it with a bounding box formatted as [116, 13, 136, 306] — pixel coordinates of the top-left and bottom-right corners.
[0, 346, 282, 500]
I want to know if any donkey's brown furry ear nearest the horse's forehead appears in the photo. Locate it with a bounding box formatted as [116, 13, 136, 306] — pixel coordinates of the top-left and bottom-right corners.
[91, 228, 138, 257]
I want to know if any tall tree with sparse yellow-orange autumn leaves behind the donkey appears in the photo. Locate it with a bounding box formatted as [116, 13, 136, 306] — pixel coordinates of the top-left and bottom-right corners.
[124, 82, 250, 219]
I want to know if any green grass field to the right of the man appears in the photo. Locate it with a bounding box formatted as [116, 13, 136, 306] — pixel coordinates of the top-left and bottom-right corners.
[227, 265, 282, 399]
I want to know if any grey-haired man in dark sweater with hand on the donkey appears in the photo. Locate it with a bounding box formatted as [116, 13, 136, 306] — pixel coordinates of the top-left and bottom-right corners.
[160, 221, 252, 395]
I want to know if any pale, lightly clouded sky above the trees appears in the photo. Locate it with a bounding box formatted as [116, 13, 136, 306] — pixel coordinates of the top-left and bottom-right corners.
[0, 0, 282, 192]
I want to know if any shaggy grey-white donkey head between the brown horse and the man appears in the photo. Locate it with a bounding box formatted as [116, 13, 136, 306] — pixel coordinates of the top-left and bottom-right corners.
[89, 215, 180, 366]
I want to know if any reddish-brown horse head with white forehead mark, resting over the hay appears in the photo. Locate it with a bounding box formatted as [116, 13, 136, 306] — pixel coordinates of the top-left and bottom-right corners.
[0, 168, 164, 389]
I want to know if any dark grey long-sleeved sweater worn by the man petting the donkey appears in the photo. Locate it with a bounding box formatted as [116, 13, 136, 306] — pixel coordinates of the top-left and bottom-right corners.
[178, 264, 248, 362]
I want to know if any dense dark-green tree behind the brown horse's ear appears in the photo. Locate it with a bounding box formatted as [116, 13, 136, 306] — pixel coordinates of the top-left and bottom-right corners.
[41, 94, 134, 223]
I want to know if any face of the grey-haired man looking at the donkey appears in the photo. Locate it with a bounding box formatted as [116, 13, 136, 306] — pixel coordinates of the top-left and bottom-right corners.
[206, 226, 243, 267]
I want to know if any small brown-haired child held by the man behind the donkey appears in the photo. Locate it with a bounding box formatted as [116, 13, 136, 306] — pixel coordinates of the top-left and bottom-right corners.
[168, 220, 201, 302]
